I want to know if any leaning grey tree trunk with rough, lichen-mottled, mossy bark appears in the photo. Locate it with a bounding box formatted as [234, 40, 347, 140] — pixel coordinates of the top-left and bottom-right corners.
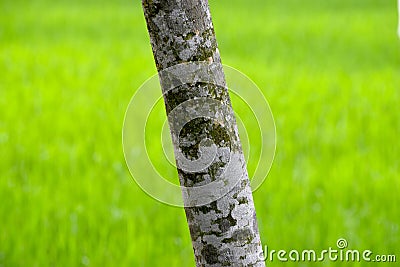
[143, 0, 265, 266]
